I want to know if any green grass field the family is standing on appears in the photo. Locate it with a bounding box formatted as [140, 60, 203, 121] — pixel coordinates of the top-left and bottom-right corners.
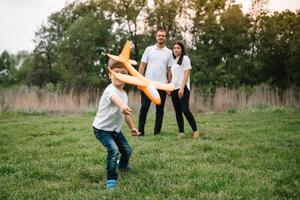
[0, 109, 300, 200]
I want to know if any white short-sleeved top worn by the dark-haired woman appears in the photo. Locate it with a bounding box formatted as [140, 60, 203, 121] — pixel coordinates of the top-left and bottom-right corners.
[171, 55, 192, 90]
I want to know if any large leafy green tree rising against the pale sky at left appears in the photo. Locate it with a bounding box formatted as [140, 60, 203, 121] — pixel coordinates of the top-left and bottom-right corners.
[27, 0, 113, 88]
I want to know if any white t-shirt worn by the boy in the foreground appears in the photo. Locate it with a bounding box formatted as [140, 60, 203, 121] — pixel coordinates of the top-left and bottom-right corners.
[93, 83, 128, 132]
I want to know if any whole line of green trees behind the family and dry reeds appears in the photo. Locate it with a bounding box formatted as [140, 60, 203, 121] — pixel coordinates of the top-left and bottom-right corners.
[0, 0, 300, 93]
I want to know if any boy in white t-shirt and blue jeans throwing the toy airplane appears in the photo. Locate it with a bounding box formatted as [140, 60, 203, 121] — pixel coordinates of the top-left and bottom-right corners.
[93, 59, 139, 189]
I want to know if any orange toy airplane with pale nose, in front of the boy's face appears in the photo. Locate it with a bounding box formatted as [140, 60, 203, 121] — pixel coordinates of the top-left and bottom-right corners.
[107, 41, 174, 105]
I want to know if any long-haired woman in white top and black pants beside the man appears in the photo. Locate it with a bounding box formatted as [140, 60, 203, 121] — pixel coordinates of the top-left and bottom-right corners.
[171, 42, 199, 139]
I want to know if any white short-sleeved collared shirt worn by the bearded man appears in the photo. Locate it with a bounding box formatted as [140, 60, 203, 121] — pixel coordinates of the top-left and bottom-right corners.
[141, 45, 172, 83]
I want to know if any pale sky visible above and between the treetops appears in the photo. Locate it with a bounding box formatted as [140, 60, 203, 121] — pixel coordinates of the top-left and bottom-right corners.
[0, 0, 300, 54]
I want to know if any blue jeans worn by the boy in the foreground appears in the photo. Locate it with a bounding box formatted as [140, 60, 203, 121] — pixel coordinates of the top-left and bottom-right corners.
[93, 127, 132, 180]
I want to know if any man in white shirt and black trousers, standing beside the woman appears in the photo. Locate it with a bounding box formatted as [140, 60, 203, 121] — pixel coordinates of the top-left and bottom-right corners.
[139, 30, 172, 136]
